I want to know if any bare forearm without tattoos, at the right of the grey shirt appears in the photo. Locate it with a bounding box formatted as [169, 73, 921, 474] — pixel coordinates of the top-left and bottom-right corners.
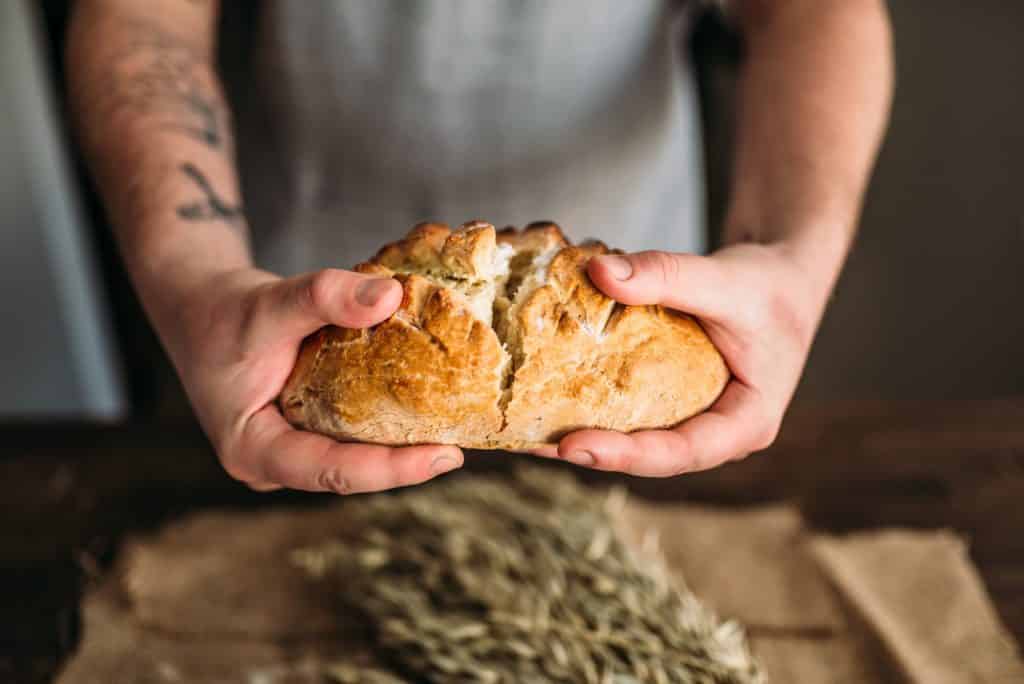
[725, 0, 892, 301]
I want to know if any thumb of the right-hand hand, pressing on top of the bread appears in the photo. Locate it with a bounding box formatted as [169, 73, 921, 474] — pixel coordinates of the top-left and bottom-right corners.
[587, 252, 733, 318]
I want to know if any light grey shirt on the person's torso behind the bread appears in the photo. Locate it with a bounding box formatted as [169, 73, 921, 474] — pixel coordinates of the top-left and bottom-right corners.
[237, 0, 705, 274]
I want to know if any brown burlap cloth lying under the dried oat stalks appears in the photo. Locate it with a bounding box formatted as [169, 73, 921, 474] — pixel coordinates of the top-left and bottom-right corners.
[58, 489, 1024, 684]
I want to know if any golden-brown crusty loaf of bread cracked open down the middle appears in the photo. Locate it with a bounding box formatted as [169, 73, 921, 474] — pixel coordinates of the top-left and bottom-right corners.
[280, 221, 729, 450]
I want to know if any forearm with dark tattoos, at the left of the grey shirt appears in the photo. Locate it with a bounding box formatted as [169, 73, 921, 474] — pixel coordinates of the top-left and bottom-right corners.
[68, 1, 251, 346]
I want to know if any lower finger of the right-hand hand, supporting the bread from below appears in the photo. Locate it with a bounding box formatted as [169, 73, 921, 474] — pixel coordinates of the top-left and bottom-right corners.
[558, 381, 771, 477]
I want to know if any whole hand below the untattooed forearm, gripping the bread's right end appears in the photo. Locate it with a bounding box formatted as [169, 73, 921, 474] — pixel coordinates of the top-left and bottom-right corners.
[538, 244, 823, 477]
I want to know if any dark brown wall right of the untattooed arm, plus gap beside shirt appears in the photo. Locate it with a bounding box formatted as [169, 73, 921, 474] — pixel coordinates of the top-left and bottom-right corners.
[697, 0, 1024, 401]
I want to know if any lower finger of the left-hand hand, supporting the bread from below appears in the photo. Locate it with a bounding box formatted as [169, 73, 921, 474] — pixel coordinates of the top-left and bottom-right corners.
[237, 405, 463, 494]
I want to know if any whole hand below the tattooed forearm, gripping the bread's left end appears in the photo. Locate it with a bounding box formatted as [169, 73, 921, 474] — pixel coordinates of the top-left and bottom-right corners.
[165, 269, 463, 494]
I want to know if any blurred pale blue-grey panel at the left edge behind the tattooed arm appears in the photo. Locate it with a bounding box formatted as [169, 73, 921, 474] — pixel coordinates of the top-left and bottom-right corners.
[0, 0, 126, 419]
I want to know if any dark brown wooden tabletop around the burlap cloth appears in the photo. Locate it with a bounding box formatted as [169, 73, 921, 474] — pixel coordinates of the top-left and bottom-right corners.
[0, 397, 1024, 682]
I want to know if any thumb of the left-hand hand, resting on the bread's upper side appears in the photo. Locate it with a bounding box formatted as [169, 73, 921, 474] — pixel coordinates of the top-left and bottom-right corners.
[253, 268, 401, 339]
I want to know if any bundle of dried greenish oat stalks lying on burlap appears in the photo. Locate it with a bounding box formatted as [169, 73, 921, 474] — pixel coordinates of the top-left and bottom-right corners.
[295, 469, 763, 684]
